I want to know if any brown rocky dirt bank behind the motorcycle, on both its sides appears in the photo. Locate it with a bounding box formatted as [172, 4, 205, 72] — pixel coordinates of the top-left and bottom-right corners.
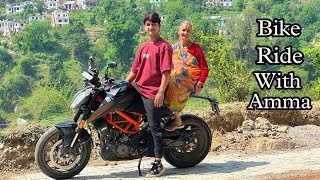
[0, 102, 320, 172]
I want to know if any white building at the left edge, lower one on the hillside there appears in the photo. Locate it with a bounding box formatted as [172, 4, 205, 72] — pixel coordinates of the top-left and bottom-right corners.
[0, 20, 24, 36]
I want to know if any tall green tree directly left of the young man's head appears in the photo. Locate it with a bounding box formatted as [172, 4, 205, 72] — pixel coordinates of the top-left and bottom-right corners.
[104, 1, 142, 75]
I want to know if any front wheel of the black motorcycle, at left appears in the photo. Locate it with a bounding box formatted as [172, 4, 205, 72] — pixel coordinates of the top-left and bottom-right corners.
[35, 127, 91, 179]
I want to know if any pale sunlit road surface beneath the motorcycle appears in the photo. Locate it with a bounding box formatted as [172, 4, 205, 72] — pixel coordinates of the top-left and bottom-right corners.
[9, 148, 320, 180]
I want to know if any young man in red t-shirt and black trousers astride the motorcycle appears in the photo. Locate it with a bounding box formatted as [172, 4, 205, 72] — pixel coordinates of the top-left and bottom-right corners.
[126, 12, 173, 177]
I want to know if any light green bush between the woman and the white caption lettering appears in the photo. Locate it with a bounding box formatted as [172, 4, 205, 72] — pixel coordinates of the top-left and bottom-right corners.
[195, 34, 251, 102]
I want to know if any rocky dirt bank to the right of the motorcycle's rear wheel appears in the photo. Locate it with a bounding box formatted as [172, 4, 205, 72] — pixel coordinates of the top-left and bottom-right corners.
[185, 102, 320, 151]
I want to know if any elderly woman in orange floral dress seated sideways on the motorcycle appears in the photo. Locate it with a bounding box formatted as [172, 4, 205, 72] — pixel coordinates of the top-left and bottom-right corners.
[165, 21, 209, 131]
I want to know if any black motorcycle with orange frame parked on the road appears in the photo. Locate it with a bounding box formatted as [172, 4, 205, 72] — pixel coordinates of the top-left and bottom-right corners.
[35, 57, 219, 179]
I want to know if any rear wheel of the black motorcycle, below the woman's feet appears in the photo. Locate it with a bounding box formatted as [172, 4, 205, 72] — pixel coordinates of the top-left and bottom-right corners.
[164, 114, 212, 168]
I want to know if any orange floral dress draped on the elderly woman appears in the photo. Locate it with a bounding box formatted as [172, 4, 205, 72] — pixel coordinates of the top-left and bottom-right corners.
[164, 43, 201, 112]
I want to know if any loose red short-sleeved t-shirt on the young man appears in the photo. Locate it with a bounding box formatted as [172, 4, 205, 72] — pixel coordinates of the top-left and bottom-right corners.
[131, 38, 173, 99]
